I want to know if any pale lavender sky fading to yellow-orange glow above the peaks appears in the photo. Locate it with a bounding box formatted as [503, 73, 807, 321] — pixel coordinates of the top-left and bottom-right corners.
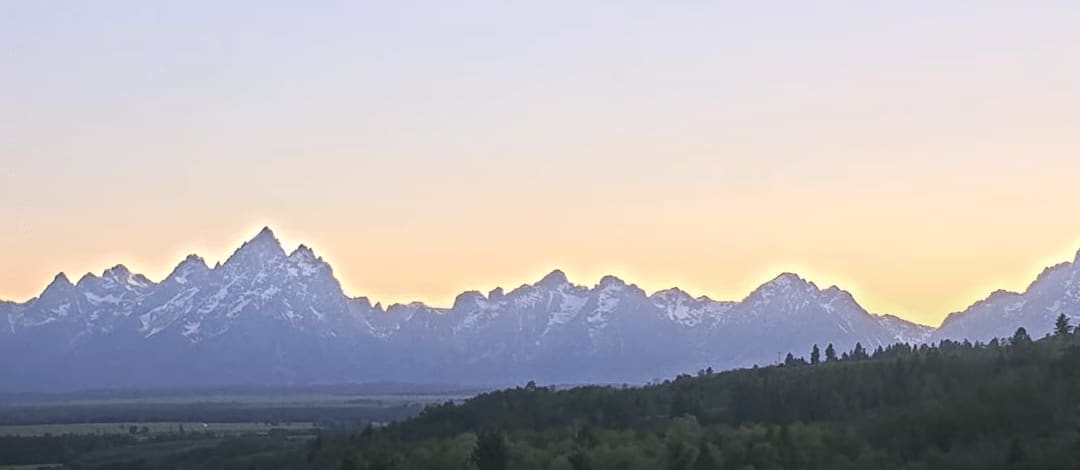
[0, 0, 1080, 325]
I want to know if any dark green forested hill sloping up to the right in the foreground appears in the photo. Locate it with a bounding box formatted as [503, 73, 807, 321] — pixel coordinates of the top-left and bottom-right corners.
[308, 318, 1080, 470]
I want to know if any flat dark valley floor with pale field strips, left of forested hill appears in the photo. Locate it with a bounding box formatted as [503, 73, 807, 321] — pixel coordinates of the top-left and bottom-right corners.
[0, 387, 472, 470]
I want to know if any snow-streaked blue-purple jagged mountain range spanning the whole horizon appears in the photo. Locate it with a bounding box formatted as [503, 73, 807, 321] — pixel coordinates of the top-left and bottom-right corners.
[0, 228, 1080, 391]
